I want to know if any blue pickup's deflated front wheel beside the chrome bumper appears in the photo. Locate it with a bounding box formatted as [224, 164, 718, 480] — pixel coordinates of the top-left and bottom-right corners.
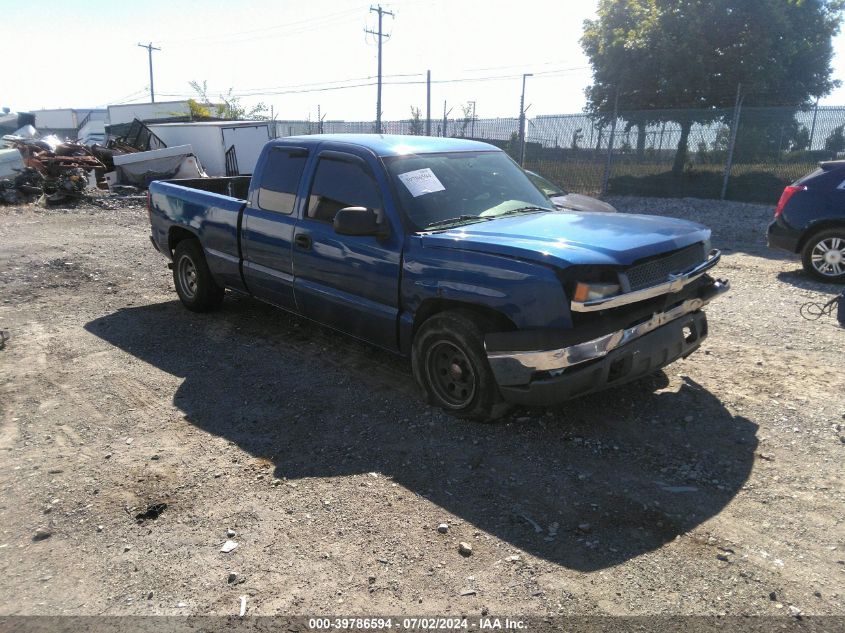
[411, 310, 510, 422]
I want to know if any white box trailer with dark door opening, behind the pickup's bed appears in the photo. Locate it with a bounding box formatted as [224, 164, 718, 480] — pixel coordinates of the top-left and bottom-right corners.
[148, 121, 274, 176]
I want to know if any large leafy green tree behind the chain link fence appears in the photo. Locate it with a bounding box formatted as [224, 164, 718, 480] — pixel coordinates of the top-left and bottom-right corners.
[581, 0, 845, 174]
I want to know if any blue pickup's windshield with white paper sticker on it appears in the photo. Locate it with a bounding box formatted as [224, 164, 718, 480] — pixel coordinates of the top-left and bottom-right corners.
[384, 151, 554, 230]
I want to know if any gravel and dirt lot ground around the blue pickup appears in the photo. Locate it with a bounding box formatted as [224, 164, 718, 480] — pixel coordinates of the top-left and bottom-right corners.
[0, 194, 845, 616]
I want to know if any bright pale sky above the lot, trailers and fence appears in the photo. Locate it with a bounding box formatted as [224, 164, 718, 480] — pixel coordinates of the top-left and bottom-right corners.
[0, 0, 845, 121]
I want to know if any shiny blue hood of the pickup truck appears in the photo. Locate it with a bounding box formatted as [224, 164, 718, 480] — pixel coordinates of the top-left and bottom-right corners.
[422, 211, 710, 267]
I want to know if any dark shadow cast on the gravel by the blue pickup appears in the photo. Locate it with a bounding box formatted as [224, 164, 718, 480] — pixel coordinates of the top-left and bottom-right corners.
[85, 299, 757, 571]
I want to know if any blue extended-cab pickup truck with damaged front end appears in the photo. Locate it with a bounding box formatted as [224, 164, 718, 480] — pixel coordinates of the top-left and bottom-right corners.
[149, 135, 728, 421]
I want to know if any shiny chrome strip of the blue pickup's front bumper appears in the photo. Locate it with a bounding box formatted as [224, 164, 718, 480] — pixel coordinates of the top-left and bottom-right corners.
[487, 280, 730, 386]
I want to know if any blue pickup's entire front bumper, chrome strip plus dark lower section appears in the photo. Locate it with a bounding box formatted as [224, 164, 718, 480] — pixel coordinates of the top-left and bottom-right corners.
[487, 280, 730, 404]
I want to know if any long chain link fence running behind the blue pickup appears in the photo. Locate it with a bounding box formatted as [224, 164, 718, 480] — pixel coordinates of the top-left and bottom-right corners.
[276, 106, 845, 204]
